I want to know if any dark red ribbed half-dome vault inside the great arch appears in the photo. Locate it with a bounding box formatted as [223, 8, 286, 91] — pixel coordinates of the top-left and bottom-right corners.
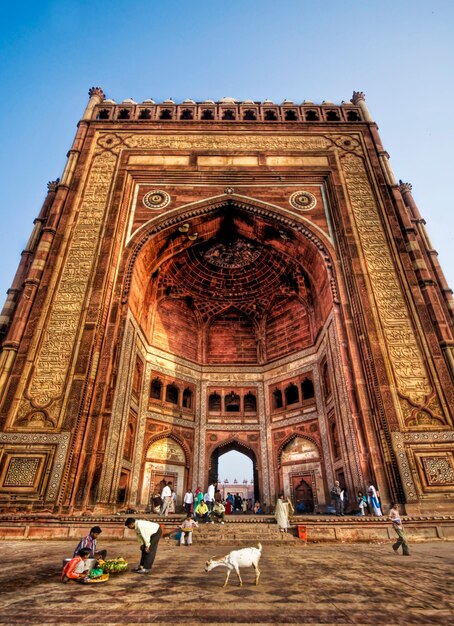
[127, 205, 334, 365]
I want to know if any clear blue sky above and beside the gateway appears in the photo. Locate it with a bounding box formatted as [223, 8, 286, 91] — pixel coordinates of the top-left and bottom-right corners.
[0, 0, 454, 299]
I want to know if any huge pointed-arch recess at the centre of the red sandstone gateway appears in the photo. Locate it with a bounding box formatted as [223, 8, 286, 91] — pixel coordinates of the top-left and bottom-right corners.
[99, 199, 366, 504]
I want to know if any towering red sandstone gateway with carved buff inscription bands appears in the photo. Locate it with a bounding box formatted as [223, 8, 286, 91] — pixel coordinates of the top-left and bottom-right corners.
[0, 88, 454, 513]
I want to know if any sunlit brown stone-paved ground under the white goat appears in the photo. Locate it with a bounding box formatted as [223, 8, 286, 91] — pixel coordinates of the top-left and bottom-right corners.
[0, 540, 454, 626]
